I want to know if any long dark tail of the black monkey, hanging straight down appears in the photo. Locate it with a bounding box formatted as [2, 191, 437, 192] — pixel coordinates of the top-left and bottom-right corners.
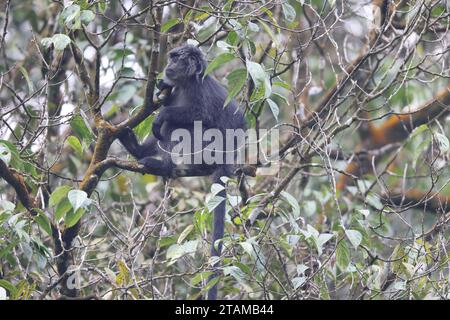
[208, 170, 227, 300]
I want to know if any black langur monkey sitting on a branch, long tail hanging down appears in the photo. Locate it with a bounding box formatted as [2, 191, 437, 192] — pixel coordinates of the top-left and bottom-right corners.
[119, 45, 246, 300]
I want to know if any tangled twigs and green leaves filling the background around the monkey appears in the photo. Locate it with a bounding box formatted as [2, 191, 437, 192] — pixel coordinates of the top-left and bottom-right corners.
[0, 0, 450, 299]
